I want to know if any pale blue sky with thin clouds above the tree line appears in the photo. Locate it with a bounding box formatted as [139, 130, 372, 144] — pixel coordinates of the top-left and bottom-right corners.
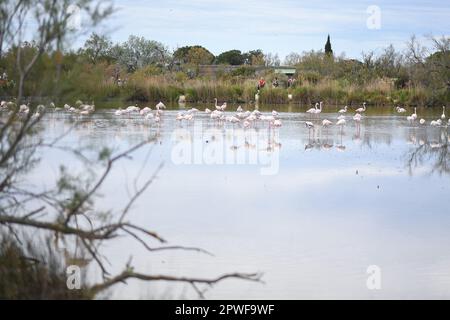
[85, 0, 450, 58]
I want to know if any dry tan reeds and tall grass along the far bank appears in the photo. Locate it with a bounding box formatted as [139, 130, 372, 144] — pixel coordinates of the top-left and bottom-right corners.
[55, 66, 442, 106]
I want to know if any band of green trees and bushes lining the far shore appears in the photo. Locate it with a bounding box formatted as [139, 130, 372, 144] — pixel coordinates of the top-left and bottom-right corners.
[0, 33, 450, 105]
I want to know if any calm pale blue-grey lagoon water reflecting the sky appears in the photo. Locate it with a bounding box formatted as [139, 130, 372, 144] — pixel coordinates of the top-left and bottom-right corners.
[33, 107, 450, 299]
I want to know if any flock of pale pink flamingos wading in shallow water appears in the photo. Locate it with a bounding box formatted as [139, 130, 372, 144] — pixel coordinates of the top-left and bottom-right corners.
[0, 99, 450, 131]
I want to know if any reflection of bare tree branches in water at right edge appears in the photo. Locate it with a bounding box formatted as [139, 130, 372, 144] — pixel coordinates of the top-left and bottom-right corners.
[408, 129, 450, 174]
